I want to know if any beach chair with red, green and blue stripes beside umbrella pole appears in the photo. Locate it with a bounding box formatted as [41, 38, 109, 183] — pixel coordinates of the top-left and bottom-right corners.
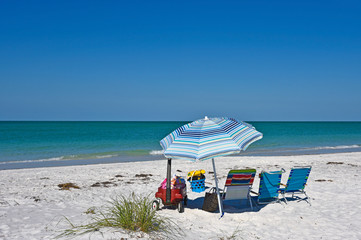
[222, 169, 256, 209]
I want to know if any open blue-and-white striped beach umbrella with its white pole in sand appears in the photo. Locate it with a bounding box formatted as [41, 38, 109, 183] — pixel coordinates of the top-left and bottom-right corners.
[160, 117, 263, 216]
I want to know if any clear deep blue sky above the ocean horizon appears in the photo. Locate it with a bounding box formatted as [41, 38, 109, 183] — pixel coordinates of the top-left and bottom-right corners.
[0, 0, 361, 121]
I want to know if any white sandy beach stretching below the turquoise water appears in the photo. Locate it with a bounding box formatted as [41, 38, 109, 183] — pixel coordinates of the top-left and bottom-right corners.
[0, 153, 361, 240]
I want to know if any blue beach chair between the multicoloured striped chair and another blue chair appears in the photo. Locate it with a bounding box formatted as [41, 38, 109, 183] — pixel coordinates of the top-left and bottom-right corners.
[251, 171, 282, 204]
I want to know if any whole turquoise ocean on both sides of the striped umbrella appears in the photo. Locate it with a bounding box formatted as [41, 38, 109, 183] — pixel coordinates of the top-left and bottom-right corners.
[0, 121, 361, 170]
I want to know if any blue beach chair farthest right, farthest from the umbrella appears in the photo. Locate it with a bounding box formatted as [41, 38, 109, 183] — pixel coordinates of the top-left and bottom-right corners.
[280, 166, 311, 205]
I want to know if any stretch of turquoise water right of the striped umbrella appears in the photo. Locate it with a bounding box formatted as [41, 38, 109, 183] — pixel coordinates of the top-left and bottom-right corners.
[247, 122, 361, 155]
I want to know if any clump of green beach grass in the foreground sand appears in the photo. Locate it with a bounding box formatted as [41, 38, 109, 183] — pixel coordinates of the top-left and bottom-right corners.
[58, 193, 183, 239]
